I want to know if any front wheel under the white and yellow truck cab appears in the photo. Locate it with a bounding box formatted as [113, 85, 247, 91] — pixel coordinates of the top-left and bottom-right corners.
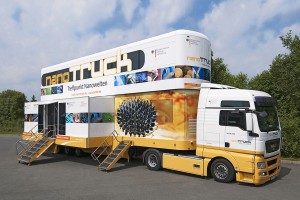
[211, 158, 235, 183]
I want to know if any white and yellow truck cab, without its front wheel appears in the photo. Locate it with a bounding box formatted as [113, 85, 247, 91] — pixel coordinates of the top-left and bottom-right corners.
[197, 83, 281, 184]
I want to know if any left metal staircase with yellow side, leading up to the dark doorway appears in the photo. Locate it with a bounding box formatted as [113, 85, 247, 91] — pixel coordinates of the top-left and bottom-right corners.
[16, 126, 55, 165]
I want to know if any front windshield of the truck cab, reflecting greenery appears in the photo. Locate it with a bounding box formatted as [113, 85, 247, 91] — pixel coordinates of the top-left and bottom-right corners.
[255, 97, 279, 132]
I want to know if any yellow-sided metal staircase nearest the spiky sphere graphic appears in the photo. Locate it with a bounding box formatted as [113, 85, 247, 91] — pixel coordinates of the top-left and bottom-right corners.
[91, 131, 132, 171]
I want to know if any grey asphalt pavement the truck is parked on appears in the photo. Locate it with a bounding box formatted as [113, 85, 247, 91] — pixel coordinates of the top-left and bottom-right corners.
[0, 135, 300, 200]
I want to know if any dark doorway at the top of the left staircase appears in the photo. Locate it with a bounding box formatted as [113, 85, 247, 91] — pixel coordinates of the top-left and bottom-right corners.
[38, 102, 58, 137]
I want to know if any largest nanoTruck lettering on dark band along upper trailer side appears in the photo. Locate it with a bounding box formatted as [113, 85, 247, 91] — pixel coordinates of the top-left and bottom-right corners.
[42, 50, 145, 86]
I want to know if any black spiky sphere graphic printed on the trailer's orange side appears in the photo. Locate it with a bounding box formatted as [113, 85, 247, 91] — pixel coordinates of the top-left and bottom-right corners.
[117, 99, 157, 137]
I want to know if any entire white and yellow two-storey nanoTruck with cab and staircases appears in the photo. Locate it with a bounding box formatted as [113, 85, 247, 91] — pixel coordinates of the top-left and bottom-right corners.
[16, 30, 281, 185]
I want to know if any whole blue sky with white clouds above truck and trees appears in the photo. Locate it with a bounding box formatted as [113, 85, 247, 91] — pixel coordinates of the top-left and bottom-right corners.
[0, 0, 300, 99]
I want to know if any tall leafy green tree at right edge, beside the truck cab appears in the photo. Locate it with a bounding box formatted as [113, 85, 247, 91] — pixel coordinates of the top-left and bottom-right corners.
[249, 31, 300, 157]
